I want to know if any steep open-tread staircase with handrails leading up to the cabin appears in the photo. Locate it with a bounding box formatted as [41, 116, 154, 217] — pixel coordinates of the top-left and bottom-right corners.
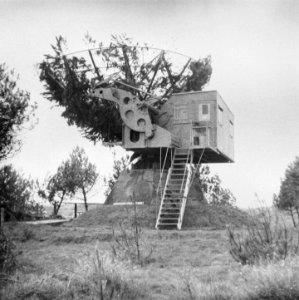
[156, 148, 192, 229]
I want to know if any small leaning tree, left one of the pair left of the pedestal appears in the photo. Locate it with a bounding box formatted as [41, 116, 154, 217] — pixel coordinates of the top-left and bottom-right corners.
[38, 160, 76, 216]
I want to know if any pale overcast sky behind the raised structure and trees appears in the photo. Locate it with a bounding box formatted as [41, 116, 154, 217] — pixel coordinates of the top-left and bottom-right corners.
[0, 0, 299, 208]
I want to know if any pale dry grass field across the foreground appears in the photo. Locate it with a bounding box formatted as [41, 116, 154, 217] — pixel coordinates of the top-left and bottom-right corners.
[0, 205, 299, 300]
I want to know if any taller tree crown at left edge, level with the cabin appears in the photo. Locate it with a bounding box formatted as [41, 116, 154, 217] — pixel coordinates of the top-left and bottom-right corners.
[0, 64, 36, 160]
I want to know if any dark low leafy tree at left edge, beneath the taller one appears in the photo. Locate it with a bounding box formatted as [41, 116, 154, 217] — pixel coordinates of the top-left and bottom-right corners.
[0, 165, 41, 220]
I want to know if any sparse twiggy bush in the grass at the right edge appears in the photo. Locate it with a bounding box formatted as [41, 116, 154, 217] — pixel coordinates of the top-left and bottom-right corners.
[227, 209, 299, 265]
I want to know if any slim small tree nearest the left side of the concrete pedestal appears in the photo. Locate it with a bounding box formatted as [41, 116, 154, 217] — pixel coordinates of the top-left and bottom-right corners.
[69, 146, 99, 211]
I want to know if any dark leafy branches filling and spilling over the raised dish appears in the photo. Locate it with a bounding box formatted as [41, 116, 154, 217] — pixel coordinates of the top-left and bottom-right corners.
[40, 36, 212, 142]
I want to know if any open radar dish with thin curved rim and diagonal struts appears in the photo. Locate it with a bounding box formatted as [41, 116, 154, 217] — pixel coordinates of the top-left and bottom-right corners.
[64, 44, 195, 105]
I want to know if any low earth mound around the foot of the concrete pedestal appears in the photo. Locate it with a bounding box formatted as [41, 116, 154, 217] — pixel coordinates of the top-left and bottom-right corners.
[69, 204, 248, 230]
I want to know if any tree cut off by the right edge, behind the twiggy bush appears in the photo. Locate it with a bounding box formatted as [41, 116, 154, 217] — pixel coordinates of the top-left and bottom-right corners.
[273, 157, 299, 226]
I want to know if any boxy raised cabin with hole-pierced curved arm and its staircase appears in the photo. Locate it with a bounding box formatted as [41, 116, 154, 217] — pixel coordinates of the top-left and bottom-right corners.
[92, 87, 234, 229]
